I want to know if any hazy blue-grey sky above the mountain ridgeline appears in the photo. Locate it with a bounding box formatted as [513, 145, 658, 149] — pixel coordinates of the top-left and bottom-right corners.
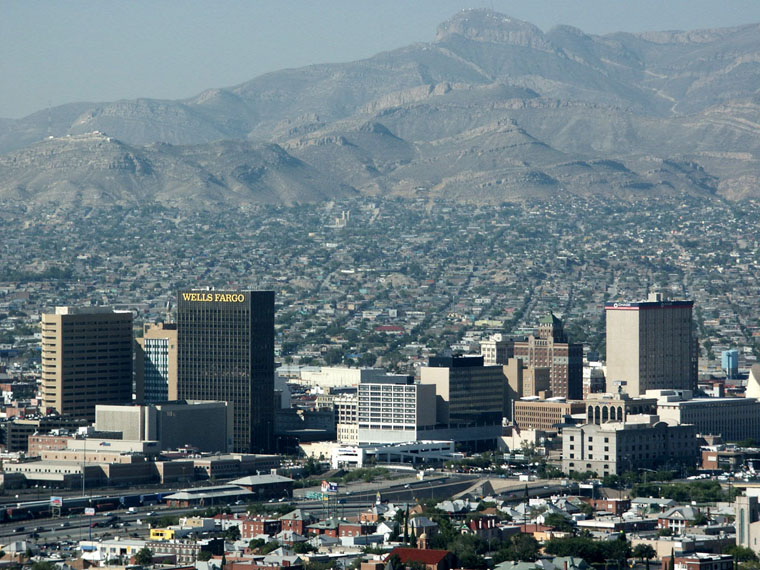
[0, 0, 760, 118]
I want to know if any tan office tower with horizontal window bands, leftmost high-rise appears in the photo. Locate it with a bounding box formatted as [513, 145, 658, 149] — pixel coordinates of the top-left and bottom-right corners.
[42, 307, 134, 421]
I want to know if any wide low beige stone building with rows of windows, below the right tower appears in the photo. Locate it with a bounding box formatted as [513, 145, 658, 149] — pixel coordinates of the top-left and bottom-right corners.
[562, 415, 699, 477]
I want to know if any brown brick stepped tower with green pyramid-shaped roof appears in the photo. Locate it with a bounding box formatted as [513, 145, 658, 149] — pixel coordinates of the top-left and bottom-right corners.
[515, 313, 583, 400]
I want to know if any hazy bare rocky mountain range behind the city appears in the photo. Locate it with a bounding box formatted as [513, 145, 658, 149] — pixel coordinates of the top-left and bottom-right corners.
[0, 10, 760, 209]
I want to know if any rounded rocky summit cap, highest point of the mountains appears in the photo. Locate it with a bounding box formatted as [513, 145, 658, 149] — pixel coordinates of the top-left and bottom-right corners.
[436, 9, 551, 50]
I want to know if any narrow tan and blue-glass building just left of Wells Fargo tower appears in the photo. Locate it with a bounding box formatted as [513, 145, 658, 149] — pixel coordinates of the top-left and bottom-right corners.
[135, 323, 177, 404]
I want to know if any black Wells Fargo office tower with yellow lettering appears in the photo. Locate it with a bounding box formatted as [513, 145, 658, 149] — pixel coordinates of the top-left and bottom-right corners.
[177, 290, 274, 453]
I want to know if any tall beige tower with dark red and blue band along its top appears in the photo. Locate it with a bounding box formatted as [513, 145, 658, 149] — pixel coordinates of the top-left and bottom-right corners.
[605, 293, 697, 396]
